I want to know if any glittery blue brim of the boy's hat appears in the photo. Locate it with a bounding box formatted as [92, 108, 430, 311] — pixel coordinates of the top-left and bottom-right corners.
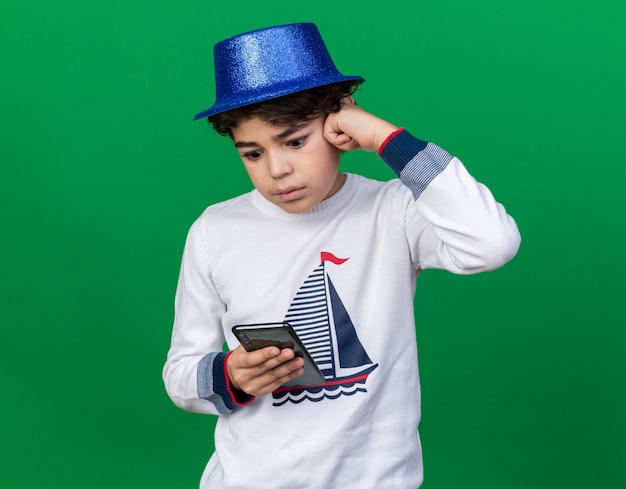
[193, 76, 365, 121]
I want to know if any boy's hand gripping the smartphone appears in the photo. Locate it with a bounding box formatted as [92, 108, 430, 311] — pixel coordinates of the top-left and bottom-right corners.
[226, 345, 304, 397]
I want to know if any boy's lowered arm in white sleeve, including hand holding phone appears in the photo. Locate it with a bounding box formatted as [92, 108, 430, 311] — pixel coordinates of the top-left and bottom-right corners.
[163, 223, 303, 414]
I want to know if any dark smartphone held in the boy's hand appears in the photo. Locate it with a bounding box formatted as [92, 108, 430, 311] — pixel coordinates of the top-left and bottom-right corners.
[232, 322, 324, 386]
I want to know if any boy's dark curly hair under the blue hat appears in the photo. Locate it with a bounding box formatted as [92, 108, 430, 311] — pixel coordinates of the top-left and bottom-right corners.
[208, 81, 359, 138]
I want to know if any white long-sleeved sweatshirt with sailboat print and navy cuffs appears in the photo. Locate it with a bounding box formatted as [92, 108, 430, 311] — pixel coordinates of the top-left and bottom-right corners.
[163, 130, 520, 489]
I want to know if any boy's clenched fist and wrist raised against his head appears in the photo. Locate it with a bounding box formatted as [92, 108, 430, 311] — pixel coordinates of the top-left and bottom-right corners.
[324, 96, 399, 151]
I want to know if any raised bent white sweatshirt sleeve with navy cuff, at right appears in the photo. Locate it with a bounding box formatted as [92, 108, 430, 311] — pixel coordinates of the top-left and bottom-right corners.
[378, 129, 521, 274]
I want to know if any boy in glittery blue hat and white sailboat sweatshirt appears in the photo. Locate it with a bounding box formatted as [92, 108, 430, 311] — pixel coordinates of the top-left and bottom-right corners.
[163, 24, 520, 489]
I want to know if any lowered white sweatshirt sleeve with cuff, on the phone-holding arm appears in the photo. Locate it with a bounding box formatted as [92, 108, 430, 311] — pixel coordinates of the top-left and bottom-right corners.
[163, 223, 254, 414]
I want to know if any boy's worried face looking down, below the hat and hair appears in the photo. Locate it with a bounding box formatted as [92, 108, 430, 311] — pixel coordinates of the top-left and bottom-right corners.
[232, 116, 346, 213]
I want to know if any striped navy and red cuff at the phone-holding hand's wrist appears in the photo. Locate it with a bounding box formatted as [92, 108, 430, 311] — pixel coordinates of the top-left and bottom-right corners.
[197, 352, 254, 414]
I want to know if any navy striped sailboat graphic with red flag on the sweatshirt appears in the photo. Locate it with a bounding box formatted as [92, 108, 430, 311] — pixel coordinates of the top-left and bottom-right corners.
[272, 251, 378, 406]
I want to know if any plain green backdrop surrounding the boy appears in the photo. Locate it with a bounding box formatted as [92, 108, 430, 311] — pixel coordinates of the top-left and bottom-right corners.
[0, 0, 626, 489]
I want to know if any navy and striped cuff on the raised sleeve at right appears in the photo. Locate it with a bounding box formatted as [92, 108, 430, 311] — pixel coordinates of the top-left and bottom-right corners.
[378, 129, 452, 200]
